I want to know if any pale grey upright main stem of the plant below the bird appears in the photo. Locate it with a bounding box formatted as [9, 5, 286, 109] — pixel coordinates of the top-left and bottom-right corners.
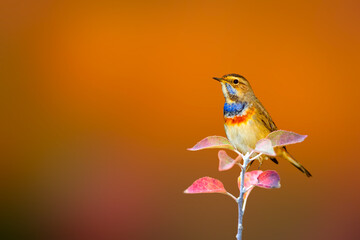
[236, 152, 252, 240]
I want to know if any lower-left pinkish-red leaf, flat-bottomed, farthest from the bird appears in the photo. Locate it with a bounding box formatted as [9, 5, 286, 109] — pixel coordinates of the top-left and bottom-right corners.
[184, 177, 226, 193]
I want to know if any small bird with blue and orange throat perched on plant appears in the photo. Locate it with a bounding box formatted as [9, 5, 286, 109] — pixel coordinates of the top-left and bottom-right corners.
[213, 74, 311, 177]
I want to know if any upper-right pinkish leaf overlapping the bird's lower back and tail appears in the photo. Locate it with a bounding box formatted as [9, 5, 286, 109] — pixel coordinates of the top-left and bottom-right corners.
[266, 130, 307, 147]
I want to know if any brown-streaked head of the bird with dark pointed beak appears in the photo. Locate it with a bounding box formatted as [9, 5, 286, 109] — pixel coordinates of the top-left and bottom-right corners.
[213, 73, 254, 102]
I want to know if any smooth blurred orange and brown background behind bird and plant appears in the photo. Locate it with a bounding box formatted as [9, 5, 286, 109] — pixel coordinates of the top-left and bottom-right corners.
[0, 0, 360, 240]
